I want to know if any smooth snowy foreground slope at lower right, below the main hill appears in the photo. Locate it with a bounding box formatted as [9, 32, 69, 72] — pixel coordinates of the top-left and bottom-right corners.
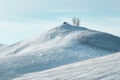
[14, 53, 120, 80]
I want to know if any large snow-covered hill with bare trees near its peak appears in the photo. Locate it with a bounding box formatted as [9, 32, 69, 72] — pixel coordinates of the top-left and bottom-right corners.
[0, 24, 120, 80]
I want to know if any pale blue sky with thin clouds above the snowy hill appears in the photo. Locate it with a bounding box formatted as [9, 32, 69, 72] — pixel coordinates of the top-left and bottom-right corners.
[0, 0, 120, 44]
